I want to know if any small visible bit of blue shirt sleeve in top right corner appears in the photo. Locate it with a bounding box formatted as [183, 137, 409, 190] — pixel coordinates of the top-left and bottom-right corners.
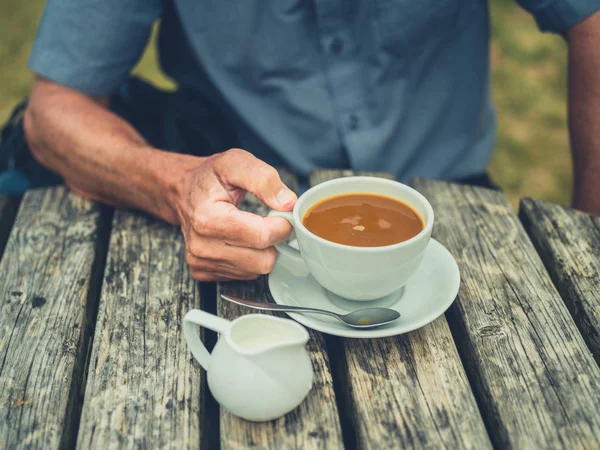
[517, 0, 600, 34]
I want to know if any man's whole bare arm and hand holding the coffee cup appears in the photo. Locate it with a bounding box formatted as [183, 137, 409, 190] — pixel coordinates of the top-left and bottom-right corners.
[24, 78, 296, 281]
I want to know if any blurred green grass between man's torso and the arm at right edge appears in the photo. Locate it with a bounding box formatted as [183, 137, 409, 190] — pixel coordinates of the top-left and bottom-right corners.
[490, 0, 572, 204]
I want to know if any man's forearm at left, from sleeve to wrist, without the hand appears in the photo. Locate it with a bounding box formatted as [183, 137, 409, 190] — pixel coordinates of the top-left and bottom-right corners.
[25, 80, 198, 223]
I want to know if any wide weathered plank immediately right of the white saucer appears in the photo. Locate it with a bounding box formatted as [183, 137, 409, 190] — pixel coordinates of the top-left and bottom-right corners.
[415, 180, 600, 448]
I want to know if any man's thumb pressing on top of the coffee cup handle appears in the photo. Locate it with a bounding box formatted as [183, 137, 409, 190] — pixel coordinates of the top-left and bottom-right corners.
[215, 149, 298, 211]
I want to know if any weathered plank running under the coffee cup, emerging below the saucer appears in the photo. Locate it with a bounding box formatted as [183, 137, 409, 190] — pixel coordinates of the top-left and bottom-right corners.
[311, 171, 491, 450]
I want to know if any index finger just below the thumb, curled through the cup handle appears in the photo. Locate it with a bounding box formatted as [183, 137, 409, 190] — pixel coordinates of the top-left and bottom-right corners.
[193, 202, 292, 249]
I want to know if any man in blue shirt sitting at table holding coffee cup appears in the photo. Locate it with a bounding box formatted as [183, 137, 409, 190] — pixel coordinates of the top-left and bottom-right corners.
[1, 0, 600, 280]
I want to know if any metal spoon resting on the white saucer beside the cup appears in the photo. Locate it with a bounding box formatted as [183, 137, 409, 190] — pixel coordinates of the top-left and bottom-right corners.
[221, 294, 400, 328]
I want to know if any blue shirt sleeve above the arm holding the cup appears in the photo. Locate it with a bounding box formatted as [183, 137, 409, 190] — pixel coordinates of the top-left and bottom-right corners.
[28, 0, 162, 96]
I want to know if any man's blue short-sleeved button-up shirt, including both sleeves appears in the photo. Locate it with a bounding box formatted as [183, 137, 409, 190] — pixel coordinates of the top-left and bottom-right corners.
[29, 0, 600, 180]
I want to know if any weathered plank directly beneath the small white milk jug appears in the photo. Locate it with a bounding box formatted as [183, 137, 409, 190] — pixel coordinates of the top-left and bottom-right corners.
[217, 171, 343, 450]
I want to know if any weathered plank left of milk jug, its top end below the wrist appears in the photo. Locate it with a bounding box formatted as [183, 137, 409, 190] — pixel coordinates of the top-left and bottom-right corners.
[77, 211, 204, 449]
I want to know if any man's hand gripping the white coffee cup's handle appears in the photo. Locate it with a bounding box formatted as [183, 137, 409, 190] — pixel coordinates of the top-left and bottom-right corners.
[176, 149, 297, 281]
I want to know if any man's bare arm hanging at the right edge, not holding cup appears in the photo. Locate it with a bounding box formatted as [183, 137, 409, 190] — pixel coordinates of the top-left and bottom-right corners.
[567, 12, 600, 215]
